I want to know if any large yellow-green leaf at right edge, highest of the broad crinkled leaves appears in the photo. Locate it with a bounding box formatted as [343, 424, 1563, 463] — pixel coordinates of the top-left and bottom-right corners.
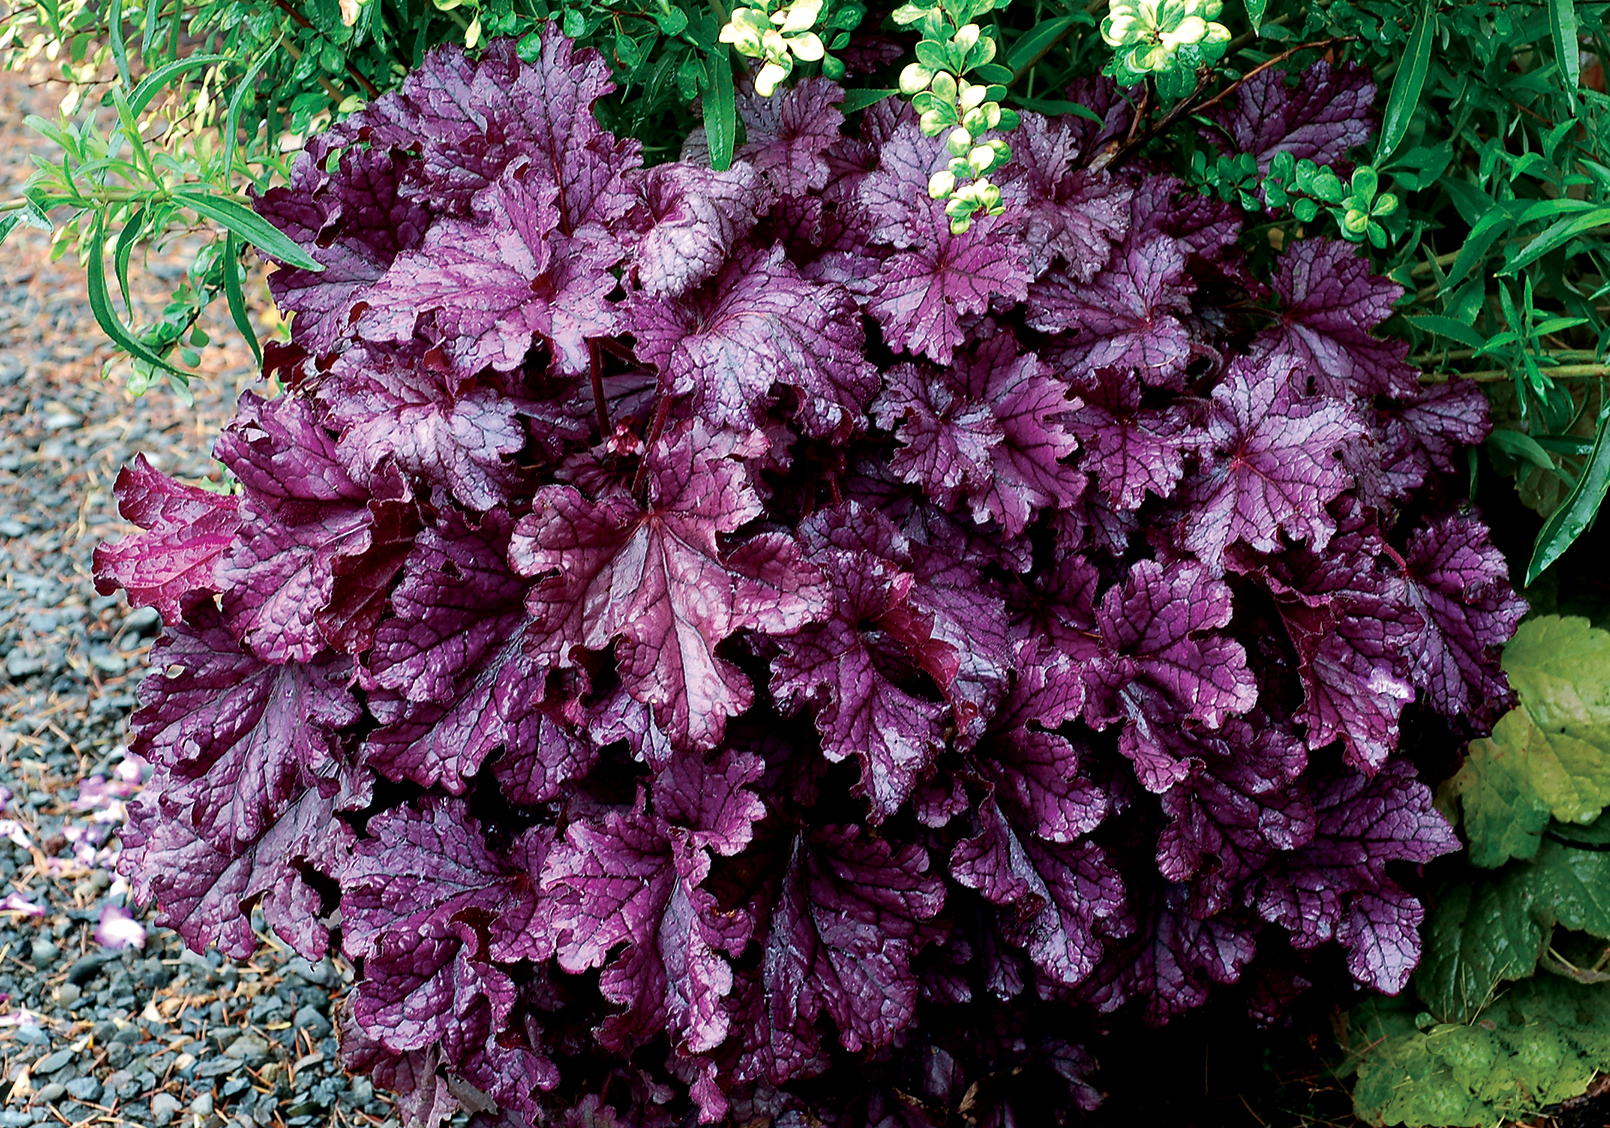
[1452, 615, 1610, 866]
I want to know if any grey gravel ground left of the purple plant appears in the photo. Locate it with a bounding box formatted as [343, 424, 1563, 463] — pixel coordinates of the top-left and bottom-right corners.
[0, 74, 396, 1128]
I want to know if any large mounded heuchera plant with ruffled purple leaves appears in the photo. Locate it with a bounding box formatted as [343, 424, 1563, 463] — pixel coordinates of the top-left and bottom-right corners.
[97, 31, 1521, 1128]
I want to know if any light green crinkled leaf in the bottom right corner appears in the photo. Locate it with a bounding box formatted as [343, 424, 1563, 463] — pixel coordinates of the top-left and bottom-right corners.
[1348, 975, 1610, 1128]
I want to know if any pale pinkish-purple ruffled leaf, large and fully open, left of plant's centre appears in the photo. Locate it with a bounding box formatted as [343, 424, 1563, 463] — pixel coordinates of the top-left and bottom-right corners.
[509, 425, 828, 748]
